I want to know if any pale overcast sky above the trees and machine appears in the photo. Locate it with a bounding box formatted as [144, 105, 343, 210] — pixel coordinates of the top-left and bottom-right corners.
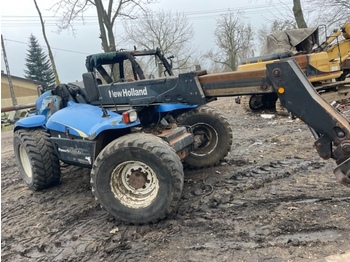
[0, 0, 292, 83]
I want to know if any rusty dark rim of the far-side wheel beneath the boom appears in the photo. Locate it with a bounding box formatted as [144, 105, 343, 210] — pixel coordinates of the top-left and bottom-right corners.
[191, 123, 218, 156]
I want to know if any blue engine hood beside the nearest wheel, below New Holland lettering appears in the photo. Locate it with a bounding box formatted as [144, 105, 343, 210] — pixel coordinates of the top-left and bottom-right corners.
[46, 101, 140, 139]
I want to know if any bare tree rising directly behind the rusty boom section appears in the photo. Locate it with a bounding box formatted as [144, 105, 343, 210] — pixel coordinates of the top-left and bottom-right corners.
[208, 11, 254, 70]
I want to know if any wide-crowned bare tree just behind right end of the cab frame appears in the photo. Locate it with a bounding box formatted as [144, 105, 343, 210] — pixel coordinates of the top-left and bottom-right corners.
[124, 11, 193, 75]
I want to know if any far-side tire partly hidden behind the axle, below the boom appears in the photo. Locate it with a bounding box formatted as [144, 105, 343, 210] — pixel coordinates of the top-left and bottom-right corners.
[176, 106, 232, 168]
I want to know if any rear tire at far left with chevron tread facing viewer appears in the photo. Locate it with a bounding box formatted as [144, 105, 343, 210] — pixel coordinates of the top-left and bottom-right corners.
[13, 129, 61, 191]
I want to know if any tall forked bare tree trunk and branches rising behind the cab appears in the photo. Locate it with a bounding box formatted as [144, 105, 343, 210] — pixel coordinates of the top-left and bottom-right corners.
[52, 0, 155, 52]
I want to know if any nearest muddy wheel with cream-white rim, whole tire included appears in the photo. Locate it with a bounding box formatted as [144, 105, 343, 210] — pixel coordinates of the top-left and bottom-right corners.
[91, 134, 184, 224]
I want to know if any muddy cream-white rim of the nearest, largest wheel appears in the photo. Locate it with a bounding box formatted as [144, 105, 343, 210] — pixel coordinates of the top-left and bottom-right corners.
[110, 161, 159, 208]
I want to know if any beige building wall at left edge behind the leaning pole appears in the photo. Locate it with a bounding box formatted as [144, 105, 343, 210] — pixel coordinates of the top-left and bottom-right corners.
[1, 73, 38, 107]
